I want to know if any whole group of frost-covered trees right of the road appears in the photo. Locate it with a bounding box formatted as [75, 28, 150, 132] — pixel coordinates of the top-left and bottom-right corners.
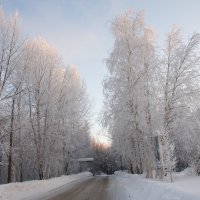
[101, 11, 200, 181]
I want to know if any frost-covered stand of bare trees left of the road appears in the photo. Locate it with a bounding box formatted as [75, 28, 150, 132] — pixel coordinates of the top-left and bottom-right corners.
[0, 9, 90, 183]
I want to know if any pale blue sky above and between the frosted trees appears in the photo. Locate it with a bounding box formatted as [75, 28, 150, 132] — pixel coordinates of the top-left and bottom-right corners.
[1, 0, 200, 139]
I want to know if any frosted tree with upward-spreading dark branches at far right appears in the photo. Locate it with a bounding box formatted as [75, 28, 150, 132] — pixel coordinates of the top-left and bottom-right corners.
[160, 28, 200, 179]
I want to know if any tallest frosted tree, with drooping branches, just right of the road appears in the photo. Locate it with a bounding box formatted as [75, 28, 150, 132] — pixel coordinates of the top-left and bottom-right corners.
[104, 12, 156, 177]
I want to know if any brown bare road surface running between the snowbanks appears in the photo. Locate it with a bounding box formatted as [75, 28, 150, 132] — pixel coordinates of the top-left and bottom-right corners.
[32, 176, 124, 200]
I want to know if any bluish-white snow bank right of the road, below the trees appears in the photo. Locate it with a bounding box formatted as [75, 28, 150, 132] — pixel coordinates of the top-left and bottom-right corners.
[113, 172, 200, 200]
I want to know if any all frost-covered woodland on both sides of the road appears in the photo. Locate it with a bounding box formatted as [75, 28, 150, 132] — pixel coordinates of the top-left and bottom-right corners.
[0, 9, 200, 186]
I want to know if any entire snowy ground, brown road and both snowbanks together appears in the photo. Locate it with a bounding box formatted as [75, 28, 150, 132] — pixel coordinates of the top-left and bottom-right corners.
[0, 172, 200, 200]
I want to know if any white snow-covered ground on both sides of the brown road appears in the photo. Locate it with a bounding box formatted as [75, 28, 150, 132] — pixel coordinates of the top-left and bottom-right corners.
[0, 169, 200, 200]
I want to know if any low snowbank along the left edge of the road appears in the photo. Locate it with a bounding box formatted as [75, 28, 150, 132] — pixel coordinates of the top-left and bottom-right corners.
[0, 172, 92, 200]
